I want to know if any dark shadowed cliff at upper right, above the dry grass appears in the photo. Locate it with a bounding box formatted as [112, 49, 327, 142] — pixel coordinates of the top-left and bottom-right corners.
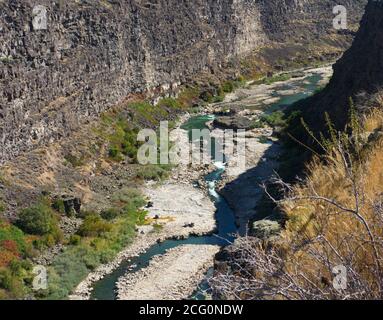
[306, 1, 383, 129]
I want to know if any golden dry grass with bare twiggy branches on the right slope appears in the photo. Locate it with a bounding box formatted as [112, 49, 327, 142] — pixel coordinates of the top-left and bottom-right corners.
[212, 110, 383, 299]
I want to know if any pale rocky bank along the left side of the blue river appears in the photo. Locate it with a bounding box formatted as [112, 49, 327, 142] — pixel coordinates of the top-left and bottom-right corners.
[70, 116, 217, 300]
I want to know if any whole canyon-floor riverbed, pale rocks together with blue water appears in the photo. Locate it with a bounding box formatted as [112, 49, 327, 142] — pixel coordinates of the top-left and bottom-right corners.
[72, 67, 332, 300]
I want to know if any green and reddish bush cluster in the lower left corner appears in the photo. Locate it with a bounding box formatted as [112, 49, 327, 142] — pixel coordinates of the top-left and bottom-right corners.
[0, 198, 73, 299]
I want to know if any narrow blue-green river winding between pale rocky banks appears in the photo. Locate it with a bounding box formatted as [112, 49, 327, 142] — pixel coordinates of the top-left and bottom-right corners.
[91, 65, 332, 300]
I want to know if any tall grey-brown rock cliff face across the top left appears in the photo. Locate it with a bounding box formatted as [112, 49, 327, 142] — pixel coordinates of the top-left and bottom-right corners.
[0, 0, 365, 160]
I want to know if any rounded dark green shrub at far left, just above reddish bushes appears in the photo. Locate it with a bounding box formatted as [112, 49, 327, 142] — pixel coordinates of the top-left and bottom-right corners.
[17, 202, 60, 236]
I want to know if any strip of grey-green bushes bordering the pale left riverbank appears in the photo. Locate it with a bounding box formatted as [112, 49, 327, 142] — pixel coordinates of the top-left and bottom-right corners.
[41, 188, 147, 299]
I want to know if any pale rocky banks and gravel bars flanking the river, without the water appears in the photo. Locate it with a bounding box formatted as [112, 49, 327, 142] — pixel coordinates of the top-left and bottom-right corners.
[71, 67, 331, 299]
